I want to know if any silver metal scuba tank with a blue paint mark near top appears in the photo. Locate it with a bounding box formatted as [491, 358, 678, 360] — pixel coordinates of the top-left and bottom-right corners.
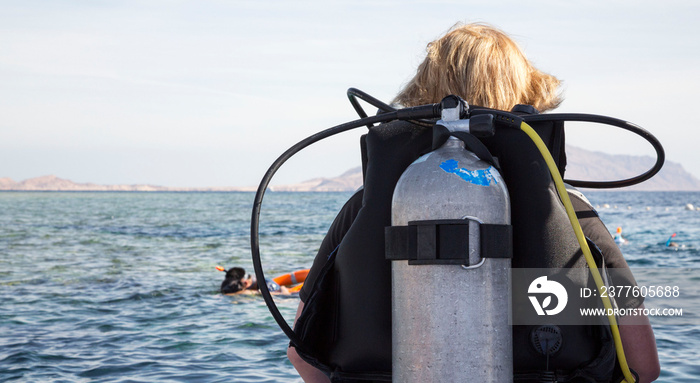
[387, 100, 513, 382]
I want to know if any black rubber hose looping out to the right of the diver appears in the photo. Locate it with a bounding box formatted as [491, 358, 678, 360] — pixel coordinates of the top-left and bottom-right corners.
[520, 113, 666, 189]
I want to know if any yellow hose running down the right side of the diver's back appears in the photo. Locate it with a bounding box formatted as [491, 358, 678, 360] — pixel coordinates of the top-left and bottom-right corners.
[520, 121, 636, 383]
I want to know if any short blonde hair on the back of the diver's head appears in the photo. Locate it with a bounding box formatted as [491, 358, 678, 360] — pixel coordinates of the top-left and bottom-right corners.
[394, 24, 562, 112]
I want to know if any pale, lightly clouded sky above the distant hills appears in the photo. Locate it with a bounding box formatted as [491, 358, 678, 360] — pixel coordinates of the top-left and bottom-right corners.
[0, 0, 700, 187]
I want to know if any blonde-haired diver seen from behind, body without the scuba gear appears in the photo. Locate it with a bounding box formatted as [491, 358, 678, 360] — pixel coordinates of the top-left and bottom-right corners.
[287, 24, 659, 382]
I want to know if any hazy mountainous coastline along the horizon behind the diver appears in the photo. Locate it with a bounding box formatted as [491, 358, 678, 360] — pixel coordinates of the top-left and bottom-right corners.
[0, 146, 700, 192]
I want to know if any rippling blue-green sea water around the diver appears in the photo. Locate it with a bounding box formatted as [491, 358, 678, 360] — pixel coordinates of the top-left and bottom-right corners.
[0, 192, 700, 383]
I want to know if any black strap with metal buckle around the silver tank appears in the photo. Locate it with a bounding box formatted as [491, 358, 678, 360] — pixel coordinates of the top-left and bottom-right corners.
[384, 218, 513, 266]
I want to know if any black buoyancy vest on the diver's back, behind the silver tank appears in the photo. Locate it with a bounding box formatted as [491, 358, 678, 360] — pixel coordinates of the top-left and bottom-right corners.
[295, 108, 615, 382]
